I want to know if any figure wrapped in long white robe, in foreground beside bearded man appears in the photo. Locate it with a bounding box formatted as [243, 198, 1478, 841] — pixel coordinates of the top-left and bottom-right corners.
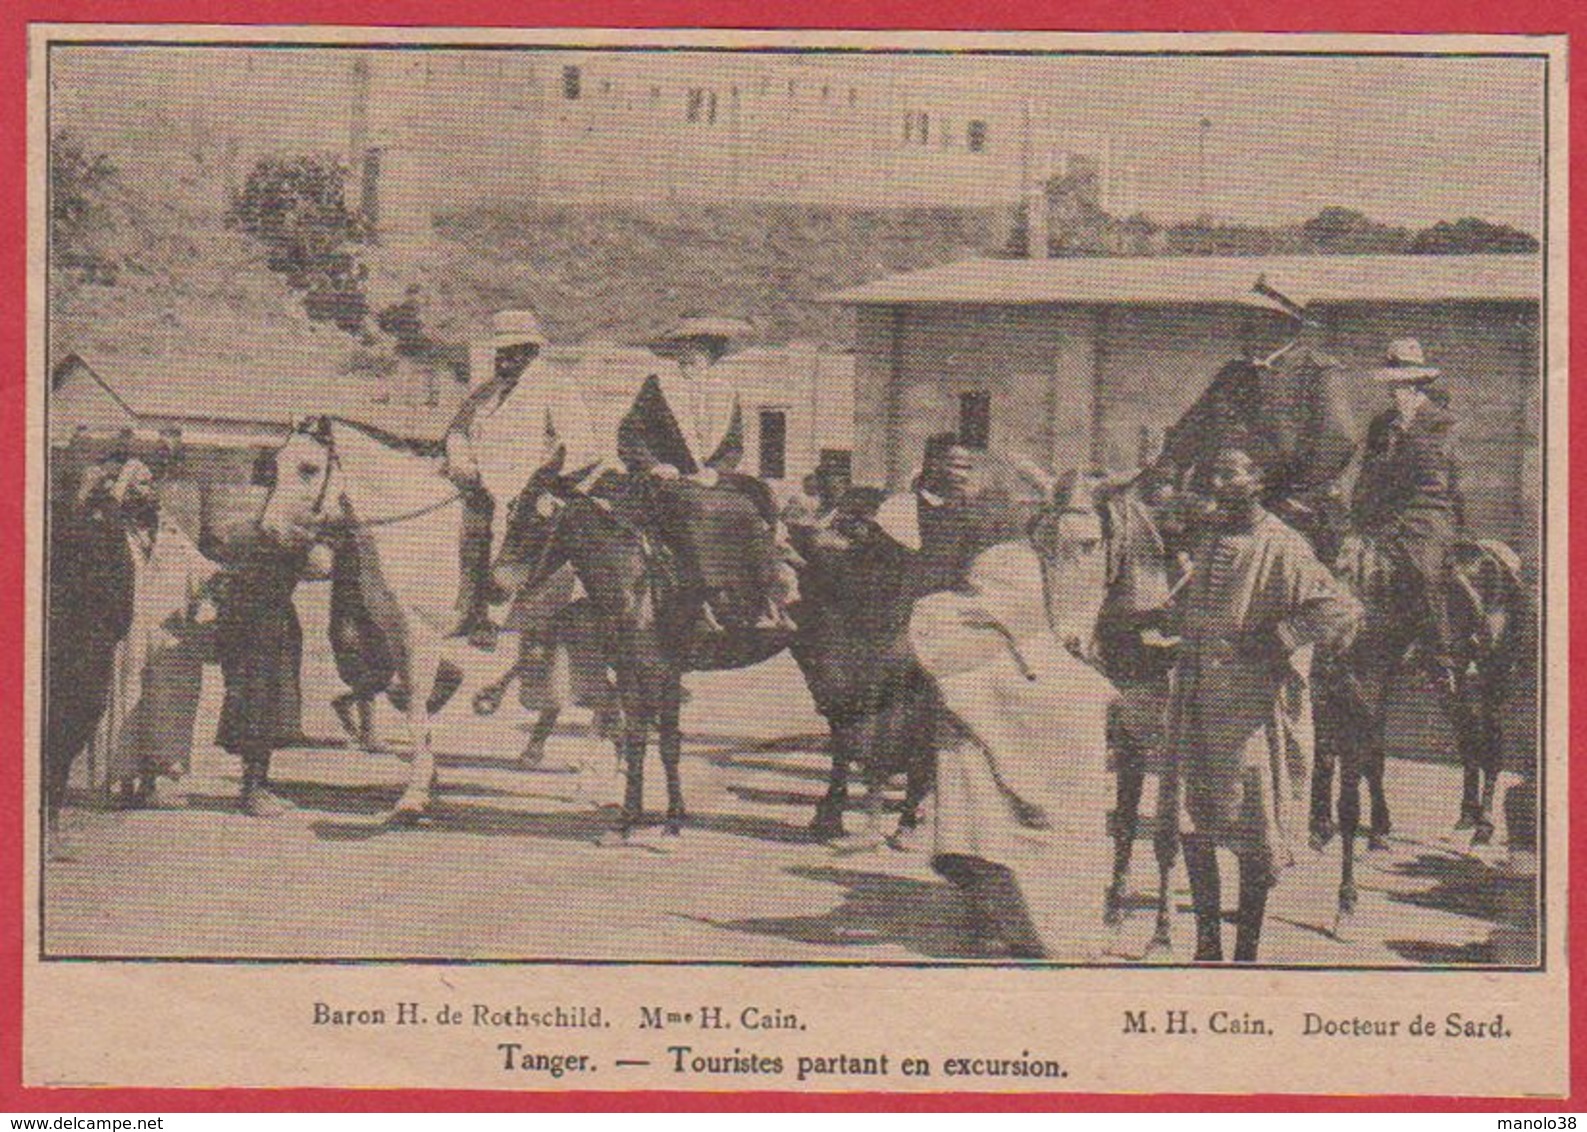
[909, 492, 1114, 962]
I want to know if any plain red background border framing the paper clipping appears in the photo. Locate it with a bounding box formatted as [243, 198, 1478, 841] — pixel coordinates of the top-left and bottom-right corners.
[0, 0, 1587, 1111]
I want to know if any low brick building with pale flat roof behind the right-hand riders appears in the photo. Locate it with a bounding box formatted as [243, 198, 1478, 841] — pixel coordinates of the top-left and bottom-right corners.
[828, 256, 1543, 562]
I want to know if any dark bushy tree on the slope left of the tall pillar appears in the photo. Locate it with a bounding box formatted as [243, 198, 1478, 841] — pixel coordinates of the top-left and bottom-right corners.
[232, 156, 368, 333]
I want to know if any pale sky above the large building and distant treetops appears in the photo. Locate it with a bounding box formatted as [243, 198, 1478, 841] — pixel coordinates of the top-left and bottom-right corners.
[51, 48, 1544, 233]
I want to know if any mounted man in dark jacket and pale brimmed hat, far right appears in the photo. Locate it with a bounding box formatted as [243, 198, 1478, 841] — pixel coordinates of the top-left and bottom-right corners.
[1351, 338, 1463, 681]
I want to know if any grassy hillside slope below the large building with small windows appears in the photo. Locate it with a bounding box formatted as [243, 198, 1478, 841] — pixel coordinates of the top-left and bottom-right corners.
[406, 205, 1008, 345]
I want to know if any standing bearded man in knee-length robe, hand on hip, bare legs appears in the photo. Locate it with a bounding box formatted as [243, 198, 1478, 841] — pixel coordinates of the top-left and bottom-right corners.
[1166, 446, 1362, 962]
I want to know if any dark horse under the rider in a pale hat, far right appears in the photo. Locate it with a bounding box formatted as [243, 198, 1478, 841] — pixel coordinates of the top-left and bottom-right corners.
[1311, 535, 1530, 913]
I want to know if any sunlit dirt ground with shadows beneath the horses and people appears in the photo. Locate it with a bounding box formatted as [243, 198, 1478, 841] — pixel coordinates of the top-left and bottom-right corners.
[44, 590, 1536, 965]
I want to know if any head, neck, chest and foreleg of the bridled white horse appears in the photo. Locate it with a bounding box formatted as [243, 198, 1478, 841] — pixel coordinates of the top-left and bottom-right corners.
[260, 416, 479, 818]
